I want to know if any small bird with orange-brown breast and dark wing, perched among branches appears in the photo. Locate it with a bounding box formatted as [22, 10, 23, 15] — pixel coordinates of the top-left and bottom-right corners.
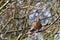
[30, 18, 42, 33]
